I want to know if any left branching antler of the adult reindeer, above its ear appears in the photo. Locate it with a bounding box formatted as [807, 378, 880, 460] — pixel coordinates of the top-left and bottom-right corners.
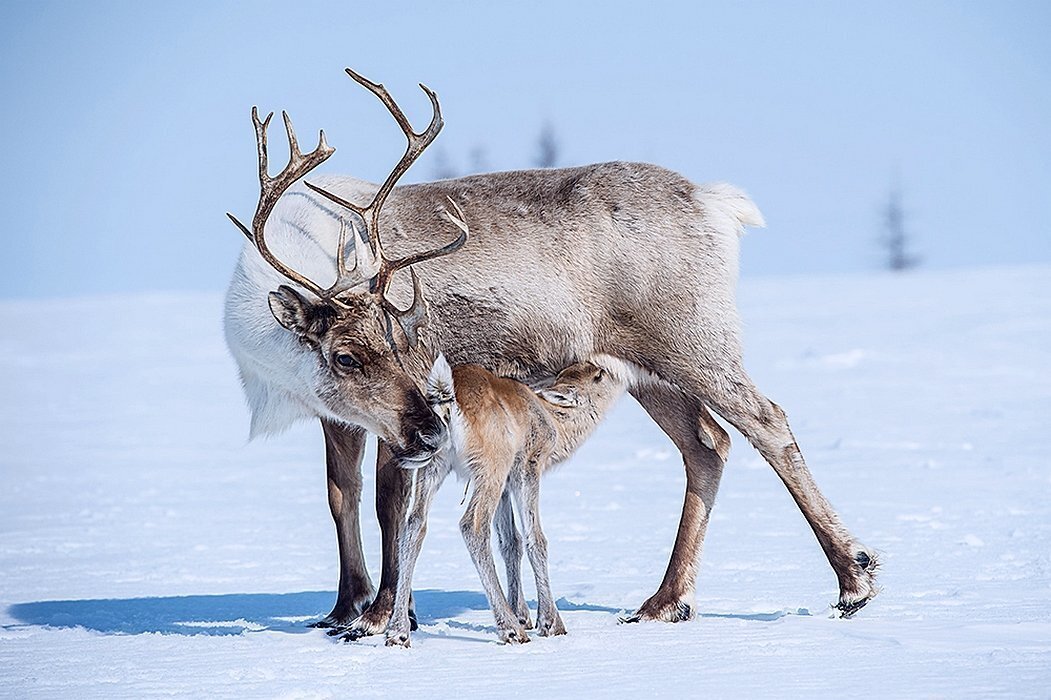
[226, 107, 338, 298]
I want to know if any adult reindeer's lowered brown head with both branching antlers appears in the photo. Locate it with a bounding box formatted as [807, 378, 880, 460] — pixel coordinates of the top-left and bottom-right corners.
[227, 68, 469, 455]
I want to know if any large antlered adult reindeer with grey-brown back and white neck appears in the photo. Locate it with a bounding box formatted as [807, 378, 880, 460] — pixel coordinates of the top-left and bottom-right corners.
[226, 68, 877, 637]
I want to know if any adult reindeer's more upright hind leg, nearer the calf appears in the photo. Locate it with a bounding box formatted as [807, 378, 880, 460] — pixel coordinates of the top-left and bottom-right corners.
[625, 384, 729, 622]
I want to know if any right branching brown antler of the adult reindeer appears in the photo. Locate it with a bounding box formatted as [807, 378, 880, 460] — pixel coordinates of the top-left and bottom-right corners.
[305, 68, 469, 346]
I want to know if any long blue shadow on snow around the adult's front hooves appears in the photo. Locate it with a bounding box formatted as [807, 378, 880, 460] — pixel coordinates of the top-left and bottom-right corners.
[7, 590, 489, 635]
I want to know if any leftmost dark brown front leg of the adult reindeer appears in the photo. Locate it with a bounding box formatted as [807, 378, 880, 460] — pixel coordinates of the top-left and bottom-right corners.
[314, 420, 374, 627]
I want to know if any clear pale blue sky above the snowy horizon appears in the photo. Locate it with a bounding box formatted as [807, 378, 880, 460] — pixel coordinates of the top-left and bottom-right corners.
[0, 1, 1051, 296]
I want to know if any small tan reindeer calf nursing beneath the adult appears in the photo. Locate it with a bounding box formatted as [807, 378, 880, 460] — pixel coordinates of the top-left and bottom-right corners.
[387, 355, 626, 646]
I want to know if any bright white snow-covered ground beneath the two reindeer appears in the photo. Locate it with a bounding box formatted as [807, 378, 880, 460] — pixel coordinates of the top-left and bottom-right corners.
[0, 267, 1051, 698]
